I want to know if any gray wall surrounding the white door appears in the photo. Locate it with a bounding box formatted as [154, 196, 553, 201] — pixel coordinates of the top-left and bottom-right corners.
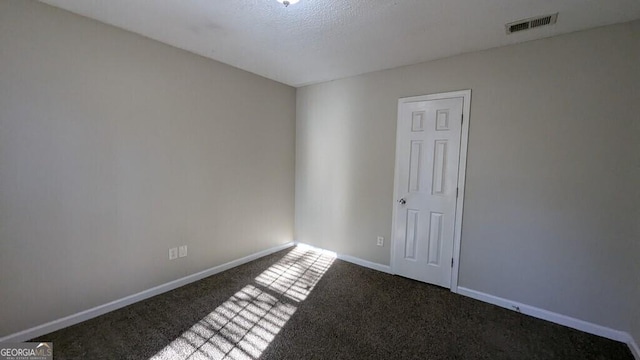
[296, 22, 640, 339]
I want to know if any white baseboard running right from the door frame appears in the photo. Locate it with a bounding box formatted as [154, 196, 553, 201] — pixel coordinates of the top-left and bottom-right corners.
[457, 286, 640, 360]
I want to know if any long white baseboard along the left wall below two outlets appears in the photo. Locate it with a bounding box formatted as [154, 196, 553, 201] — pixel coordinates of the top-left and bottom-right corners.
[0, 242, 294, 343]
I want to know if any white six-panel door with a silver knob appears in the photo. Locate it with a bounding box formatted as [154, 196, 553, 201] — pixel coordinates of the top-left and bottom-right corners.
[393, 97, 466, 288]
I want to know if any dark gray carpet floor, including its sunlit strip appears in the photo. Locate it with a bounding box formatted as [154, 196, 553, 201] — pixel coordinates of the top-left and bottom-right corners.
[33, 249, 633, 360]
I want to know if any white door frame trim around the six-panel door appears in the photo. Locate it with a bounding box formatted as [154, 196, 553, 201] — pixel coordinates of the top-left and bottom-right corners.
[389, 89, 471, 293]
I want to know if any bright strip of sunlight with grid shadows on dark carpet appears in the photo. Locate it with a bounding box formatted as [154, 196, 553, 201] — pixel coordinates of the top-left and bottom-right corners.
[150, 246, 335, 360]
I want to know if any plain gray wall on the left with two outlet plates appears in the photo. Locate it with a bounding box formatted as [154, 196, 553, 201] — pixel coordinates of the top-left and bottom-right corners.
[0, 0, 295, 337]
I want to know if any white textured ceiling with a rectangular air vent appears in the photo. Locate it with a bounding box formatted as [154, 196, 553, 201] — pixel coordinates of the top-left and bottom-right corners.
[41, 0, 640, 86]
